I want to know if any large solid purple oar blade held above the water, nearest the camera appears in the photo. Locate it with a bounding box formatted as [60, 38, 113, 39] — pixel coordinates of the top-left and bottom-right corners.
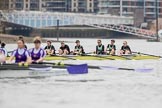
[67, 64, 88, 74]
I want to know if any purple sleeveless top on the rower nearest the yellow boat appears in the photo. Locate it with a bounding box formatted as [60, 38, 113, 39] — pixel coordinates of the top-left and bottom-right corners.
[31, 48, 44, 61]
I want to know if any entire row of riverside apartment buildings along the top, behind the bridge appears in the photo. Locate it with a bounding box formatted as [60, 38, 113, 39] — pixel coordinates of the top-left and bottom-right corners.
[0, 0, 162, 21]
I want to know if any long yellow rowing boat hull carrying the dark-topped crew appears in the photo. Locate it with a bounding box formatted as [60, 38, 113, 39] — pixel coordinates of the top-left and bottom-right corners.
[45, 54, 160, 61]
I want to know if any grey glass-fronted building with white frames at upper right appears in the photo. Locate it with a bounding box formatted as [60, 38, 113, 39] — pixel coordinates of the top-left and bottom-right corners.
[98, 0, 162, 21]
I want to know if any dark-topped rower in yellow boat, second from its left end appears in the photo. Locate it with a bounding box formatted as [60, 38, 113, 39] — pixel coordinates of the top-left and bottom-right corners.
[59, 41, 70, 55]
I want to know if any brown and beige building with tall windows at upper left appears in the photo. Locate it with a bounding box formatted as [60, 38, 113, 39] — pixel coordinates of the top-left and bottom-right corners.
[0, 0, 98, 13]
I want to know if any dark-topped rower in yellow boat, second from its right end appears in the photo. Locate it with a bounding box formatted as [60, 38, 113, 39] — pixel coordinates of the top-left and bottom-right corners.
[106, 40, 116, 55]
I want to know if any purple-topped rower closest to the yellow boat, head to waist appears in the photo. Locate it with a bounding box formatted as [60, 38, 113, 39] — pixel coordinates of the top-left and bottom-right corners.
[29, 37, 46, 63]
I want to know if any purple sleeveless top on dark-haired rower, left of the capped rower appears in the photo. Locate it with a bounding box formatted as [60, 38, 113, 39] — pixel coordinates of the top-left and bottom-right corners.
[15, 49, 27, 63]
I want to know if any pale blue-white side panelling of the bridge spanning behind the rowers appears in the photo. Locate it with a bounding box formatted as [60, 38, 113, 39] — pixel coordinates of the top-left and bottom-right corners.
[0, 11, 133, 28]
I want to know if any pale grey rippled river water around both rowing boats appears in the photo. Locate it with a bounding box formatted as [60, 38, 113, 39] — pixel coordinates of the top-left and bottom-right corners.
[0, 39, 162, 108]
